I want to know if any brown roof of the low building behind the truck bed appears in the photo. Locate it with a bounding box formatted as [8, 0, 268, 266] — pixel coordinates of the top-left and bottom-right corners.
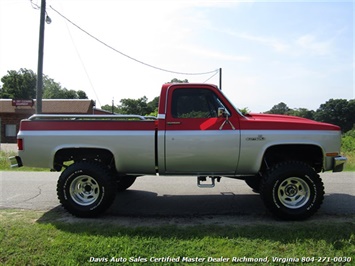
[0, 99, 95, 114]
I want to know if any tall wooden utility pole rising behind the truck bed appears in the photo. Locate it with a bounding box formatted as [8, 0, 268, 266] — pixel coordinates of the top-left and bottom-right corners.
[36, 0, 46, 114]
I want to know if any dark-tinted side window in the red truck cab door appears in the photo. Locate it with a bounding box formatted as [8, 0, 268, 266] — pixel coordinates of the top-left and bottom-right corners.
[171, 89, 228, 118]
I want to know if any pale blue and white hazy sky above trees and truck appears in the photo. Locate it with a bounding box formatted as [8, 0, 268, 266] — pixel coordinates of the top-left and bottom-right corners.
[0, 0, 355, 113]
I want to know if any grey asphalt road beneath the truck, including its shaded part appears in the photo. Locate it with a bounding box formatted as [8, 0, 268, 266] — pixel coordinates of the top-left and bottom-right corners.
[0, 172, 355, 217]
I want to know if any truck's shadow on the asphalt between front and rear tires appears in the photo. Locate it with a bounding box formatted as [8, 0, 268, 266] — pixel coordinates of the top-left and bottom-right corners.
[106, 190, 266, 216]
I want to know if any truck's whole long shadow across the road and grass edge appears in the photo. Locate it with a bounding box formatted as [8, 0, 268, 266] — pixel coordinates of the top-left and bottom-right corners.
[37, 190, 355, 227]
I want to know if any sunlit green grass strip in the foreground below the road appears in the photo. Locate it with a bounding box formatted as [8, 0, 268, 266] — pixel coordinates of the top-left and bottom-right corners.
[0, 210, 355, 265]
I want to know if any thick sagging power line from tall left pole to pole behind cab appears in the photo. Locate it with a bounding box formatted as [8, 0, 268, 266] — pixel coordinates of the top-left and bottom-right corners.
[50, 6, 219, 76]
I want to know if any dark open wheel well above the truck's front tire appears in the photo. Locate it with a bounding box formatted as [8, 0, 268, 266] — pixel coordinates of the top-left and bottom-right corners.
[262, 144, 323, 173]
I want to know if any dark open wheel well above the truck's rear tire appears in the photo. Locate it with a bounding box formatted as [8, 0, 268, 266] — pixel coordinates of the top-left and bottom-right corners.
[53, 148, 114, 171]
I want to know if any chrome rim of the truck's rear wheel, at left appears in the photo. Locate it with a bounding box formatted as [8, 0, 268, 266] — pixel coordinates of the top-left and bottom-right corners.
[69, 175, 100, 206]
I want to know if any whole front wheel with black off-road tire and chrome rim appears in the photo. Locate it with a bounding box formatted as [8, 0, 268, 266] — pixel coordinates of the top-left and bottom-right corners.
[260, 161, 324, 220]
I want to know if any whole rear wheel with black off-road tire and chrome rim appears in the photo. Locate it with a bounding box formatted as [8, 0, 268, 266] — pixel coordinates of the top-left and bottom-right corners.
[57, 161, 116, 217]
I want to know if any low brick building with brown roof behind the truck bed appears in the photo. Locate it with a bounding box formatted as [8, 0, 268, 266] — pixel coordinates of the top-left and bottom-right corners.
[0, 99, 109, 143]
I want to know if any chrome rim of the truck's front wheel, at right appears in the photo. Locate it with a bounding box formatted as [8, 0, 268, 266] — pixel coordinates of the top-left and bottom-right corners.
[277, 177, 310, 209]
